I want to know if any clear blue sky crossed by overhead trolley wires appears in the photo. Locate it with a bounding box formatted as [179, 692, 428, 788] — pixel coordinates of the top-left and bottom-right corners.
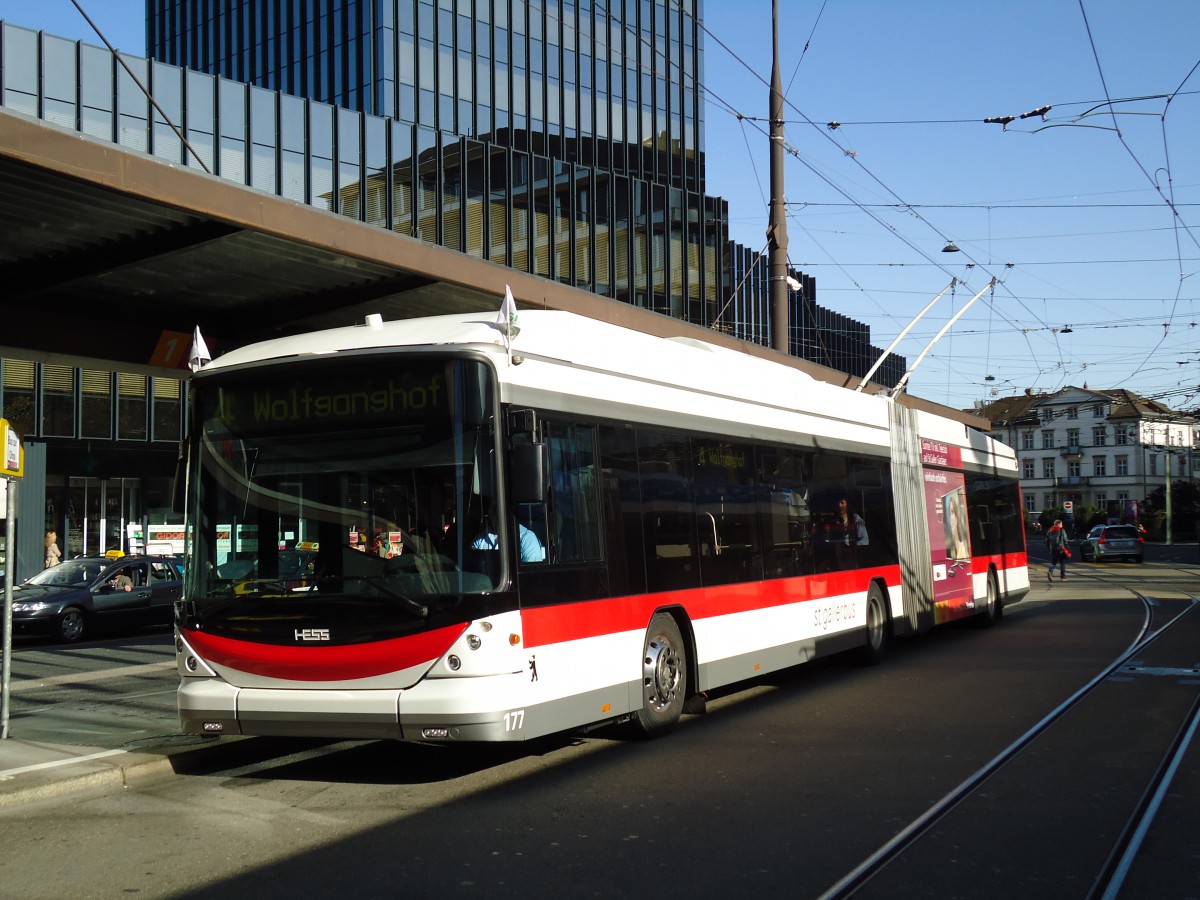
[0, 0, 1200, 409]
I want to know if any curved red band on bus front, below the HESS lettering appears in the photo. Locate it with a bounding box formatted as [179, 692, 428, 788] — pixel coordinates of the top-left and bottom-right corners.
[184, 623, 466, 682]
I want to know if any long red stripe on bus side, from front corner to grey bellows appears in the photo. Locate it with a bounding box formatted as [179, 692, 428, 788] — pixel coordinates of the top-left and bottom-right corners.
[521, 565, 900, 647]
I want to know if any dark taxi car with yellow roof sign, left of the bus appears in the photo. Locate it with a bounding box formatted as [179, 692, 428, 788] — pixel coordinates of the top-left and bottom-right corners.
[12, 557, 184, 643]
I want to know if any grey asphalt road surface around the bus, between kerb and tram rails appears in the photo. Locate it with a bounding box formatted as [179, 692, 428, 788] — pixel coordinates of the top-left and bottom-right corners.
[0, 556, 1200, 898]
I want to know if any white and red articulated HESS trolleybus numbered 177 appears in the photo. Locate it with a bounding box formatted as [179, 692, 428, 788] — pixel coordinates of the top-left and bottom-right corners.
[176, 311, 1030, 742]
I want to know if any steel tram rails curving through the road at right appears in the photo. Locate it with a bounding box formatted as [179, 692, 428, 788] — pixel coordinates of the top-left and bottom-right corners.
[820, 585, 1200, 900]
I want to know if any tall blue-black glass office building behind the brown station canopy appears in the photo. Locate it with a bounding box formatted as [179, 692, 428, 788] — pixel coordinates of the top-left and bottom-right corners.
[0, 0, 905, 571]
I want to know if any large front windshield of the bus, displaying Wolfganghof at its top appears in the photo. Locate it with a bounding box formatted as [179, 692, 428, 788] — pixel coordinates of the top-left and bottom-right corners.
[185, 355, 500, 618]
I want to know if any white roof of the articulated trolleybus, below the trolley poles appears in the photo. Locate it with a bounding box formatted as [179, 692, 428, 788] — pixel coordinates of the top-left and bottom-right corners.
[205, 310, 991, 460]
